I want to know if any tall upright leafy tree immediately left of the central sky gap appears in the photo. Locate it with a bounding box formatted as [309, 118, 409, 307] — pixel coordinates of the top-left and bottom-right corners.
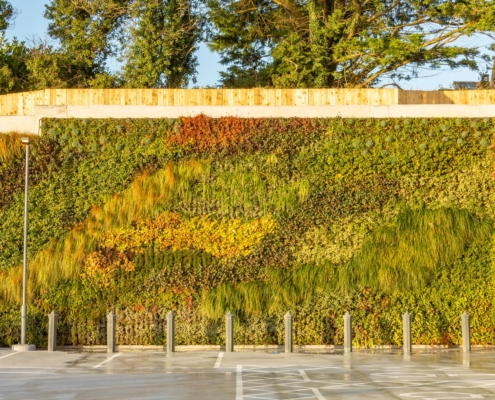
[121, 0, 202, 88]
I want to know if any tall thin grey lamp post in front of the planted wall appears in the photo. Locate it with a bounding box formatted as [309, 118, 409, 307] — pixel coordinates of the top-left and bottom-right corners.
[12, 137, 36, 351]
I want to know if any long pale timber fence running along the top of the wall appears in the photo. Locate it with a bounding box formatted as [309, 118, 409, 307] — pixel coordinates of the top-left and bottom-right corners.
[0, 88, 495, 116]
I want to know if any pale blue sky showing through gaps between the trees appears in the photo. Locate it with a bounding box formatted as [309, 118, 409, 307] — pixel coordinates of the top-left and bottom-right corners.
[7, 0, 489, 90]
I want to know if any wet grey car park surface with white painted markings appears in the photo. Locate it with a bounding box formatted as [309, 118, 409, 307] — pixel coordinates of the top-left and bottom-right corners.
[0, 349, 495, 400]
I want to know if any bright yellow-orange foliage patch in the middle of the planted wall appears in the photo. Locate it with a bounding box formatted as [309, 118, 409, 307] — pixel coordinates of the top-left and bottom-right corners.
[81, 212, 277, 287]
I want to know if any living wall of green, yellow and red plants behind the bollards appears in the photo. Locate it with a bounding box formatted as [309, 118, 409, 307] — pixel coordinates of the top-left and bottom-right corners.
[0, 116, 495, 346]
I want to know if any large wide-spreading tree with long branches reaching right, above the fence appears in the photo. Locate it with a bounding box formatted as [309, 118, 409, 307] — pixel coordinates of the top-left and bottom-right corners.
[209, 0, 495, 87]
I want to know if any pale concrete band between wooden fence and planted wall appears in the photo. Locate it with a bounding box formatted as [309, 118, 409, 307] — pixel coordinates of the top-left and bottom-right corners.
[0, 104, 495, 134]
